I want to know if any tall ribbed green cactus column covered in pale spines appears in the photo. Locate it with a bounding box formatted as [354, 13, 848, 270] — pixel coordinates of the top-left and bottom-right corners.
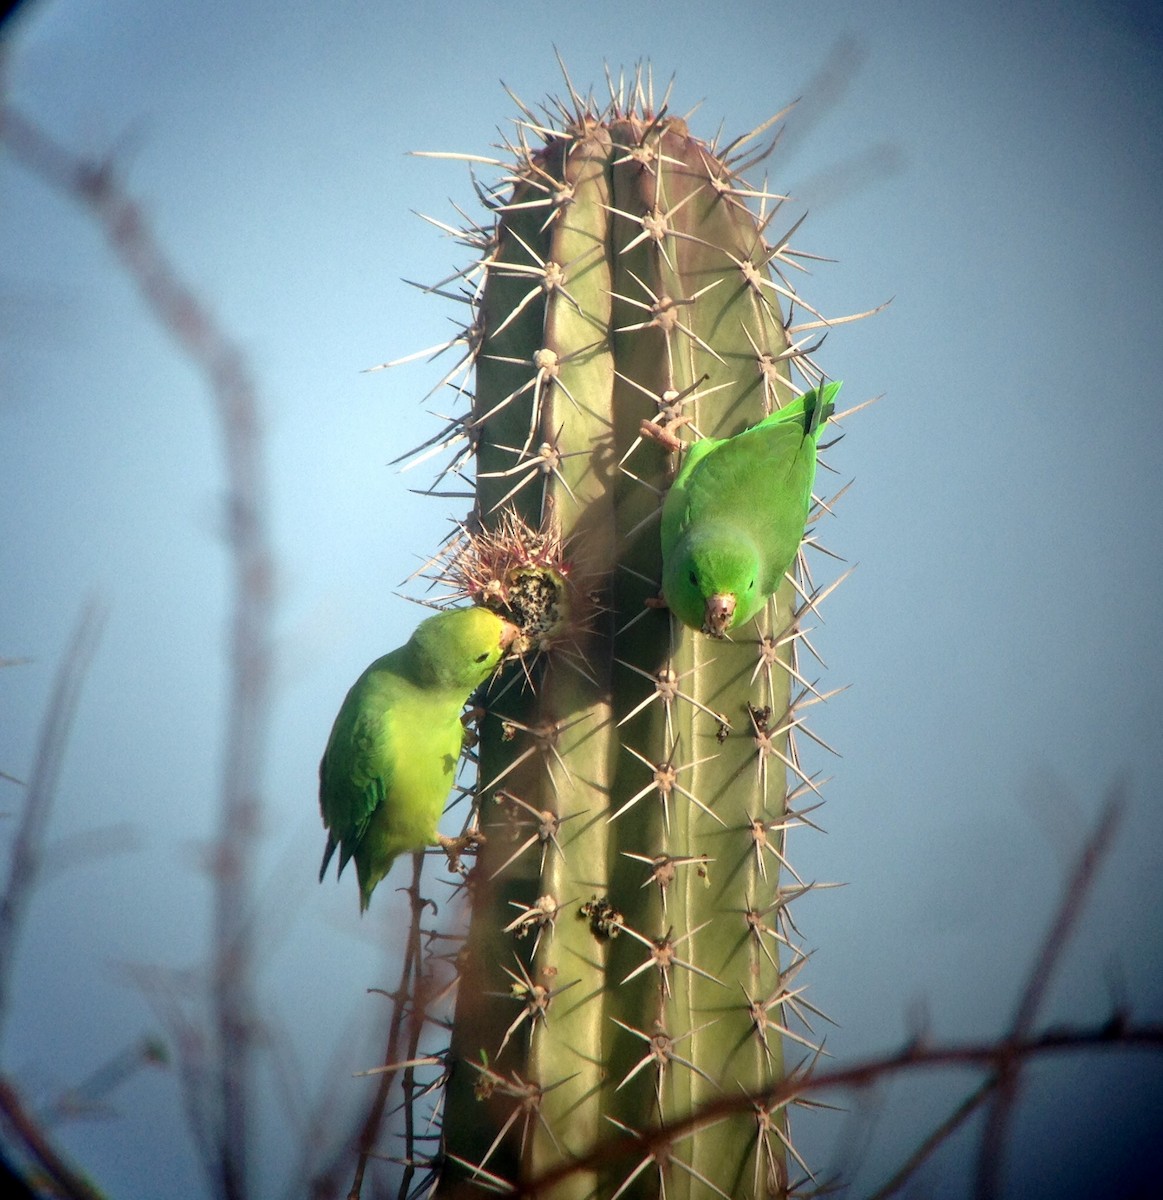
[393, 76, 849, 1200]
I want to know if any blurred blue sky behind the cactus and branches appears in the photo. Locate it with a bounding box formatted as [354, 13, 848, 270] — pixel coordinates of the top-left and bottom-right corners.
[0, 0, 1163, 1196]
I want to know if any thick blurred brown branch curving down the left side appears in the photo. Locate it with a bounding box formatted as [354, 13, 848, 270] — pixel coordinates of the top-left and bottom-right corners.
[0, 107, 272, 1200]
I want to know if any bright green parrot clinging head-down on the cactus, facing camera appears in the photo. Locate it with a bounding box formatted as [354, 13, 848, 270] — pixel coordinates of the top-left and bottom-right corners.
[663, 383, 840, 637]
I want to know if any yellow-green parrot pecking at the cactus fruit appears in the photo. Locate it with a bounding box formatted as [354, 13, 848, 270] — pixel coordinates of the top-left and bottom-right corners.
[319, 607, 517, 912]
